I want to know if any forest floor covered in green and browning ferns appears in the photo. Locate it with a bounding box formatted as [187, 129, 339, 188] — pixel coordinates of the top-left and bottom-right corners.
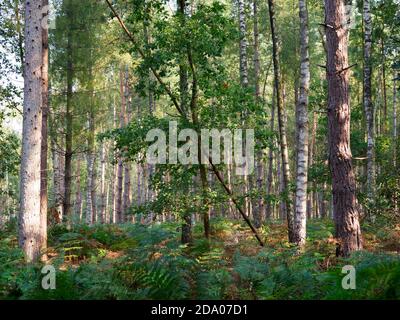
[0, 219, 400, 299]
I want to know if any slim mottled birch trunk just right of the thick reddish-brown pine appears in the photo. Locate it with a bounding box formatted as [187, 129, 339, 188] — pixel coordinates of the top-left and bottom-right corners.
[363, 0, 375, 208]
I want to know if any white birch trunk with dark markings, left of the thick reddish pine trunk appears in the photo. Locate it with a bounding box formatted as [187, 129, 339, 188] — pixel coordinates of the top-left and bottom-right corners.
[294, 0, 310, 246]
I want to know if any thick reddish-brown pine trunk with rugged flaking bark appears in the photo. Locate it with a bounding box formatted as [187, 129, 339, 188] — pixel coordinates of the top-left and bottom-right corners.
[325, 0, 362, 256]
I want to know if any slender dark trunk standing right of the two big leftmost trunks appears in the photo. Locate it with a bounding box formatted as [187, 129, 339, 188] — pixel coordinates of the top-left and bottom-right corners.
[63, 2, 73, 225]
